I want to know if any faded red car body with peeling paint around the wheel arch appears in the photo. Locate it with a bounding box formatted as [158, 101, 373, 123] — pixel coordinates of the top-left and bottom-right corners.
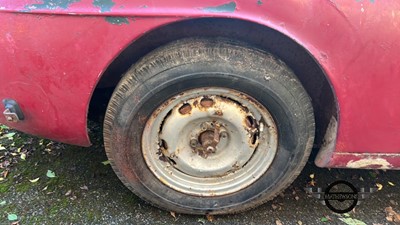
[0, 0, 400, 169]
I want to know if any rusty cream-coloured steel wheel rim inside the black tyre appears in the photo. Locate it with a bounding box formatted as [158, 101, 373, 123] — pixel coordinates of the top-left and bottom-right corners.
[141, 87, 278, 196]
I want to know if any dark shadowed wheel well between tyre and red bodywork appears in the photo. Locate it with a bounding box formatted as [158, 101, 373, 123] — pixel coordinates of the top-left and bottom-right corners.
[89, 18, 338, 148]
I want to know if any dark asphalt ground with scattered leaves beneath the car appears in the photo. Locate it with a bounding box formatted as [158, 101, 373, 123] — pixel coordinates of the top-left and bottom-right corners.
[0, 126, 400, 225]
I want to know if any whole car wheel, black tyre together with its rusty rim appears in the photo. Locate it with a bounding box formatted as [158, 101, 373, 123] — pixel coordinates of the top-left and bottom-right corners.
[104, 39, 314, 214]
